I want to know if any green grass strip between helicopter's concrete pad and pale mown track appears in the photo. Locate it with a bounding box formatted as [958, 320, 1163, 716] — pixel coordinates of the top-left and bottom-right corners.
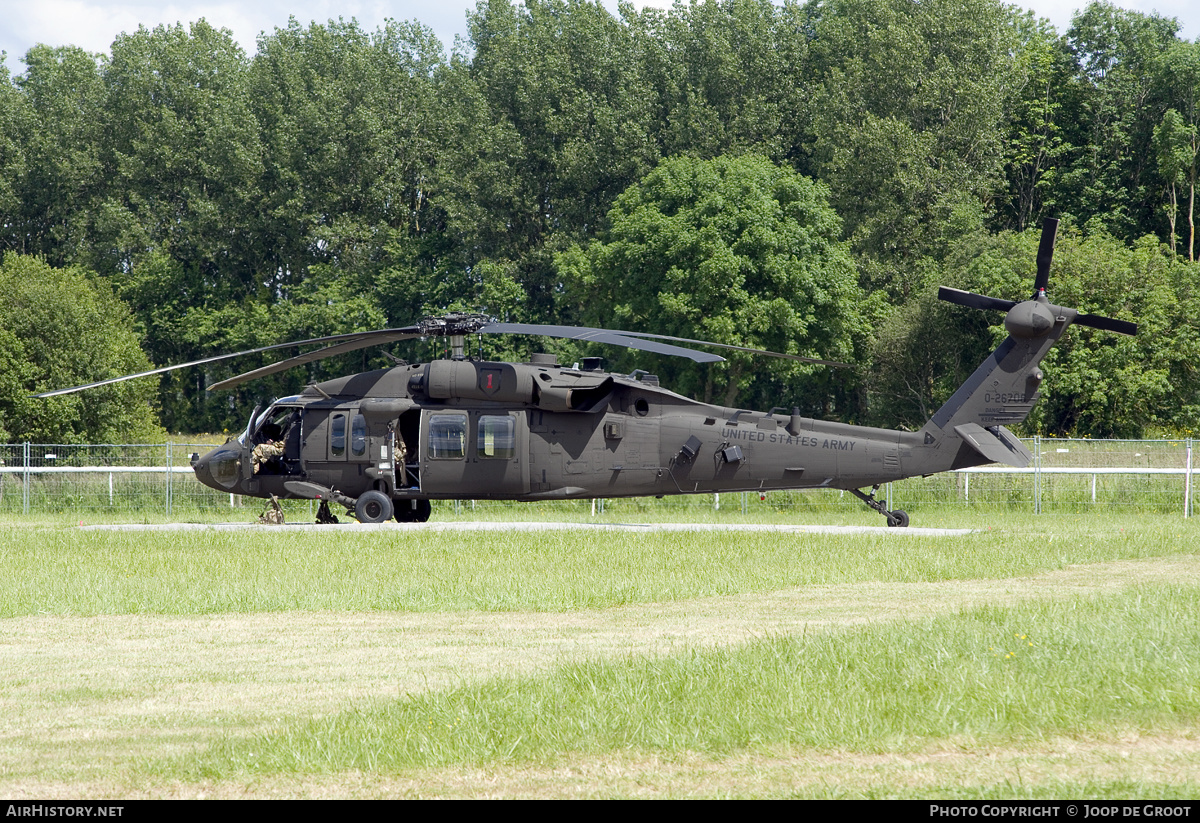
[0, 511, 1200, 617]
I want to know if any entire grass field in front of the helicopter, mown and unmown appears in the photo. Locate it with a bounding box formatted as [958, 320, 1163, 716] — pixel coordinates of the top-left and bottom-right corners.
[0, 509, 1200, 798]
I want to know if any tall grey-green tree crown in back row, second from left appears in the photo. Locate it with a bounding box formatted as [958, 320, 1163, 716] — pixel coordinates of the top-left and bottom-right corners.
[94, 20, 262, 289]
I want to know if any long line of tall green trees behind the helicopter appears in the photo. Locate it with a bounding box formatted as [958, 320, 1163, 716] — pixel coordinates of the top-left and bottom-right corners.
[0, 0, 1200, 441]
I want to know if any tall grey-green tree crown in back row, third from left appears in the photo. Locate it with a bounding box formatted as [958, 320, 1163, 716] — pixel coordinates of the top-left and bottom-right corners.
[250, 19, 444, 309]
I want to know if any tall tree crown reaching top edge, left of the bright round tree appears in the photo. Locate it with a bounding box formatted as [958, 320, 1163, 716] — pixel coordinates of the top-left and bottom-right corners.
[437, 0, 658, 322]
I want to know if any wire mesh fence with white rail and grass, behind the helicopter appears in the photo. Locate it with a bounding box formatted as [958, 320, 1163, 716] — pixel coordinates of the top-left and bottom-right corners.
[0, 437, 1194, 517]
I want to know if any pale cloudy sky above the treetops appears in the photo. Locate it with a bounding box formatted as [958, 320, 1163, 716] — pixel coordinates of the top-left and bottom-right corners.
[0, 0, 1200, 74]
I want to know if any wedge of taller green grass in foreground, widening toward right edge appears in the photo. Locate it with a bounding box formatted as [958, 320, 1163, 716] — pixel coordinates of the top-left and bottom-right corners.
[174, 585, 1200, 794]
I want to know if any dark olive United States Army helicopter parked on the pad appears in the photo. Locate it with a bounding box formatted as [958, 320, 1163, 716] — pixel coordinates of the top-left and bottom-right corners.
[40, 221, 1136, 527]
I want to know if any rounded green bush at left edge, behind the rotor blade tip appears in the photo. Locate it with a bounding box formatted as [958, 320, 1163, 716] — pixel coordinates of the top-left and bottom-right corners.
[0, 254, 164, 443]
